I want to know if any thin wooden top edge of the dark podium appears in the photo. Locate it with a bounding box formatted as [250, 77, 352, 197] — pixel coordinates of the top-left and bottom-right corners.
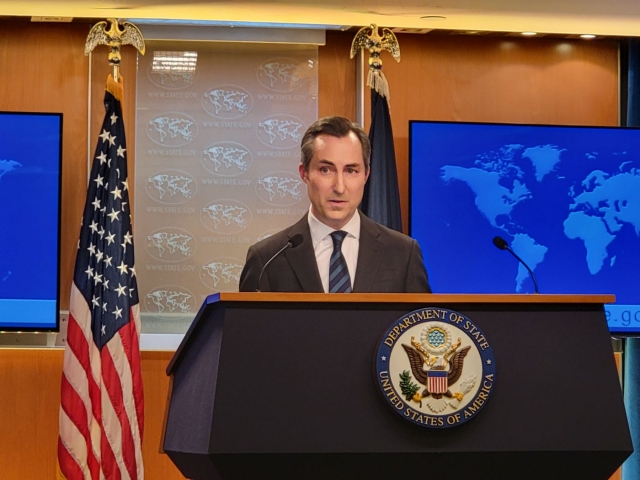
[214, 292, 616, 304]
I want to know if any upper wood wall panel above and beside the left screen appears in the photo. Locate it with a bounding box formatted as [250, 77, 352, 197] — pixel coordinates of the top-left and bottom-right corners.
[0, 22, 89, 310]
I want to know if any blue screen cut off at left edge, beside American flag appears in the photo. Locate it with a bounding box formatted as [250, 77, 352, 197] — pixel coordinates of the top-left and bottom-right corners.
[0, 112, 62, 331]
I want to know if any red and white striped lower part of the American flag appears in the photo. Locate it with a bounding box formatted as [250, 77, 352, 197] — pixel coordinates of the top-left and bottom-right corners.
[58, 284, 144, 480]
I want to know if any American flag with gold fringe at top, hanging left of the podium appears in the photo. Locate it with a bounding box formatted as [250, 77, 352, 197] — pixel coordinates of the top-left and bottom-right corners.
[58, 76, 144, 480]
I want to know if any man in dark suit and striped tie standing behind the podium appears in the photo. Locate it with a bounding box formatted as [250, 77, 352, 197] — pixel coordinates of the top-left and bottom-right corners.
[240, 117, 431, 293]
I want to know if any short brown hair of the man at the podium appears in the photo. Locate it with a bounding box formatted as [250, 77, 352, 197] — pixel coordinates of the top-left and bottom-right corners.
[300, 116, 371, 171]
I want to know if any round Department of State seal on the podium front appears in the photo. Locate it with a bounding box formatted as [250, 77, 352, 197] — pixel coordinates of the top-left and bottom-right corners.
[376, 307, 496, 428]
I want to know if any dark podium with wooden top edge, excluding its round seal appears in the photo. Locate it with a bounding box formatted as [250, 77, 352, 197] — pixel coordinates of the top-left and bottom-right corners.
[162, 293, 633, 480]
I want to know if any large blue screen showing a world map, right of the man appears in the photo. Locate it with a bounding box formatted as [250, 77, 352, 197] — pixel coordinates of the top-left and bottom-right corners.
[409, 121, 640, 335]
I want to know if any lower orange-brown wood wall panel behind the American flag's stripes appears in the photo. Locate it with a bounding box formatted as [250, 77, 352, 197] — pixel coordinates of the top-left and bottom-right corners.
[0, 348, 184, 480]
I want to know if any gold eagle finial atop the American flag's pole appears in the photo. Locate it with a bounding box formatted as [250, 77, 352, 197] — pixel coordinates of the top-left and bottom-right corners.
[84, 18, 145, 81]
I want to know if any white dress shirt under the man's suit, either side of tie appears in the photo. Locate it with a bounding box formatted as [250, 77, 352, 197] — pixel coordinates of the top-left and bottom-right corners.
[308, 209, 360, 293]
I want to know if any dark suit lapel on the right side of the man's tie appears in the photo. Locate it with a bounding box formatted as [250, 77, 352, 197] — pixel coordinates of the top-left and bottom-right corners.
[353, 214, 386, 293]
